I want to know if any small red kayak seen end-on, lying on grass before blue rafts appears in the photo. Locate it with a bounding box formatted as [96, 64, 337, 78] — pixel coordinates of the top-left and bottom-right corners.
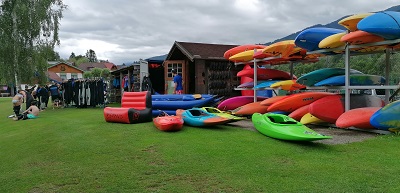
[153, 115, 183, 131]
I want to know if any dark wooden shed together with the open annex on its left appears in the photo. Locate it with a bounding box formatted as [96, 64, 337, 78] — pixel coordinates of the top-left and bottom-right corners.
[107, 41, 243, 102]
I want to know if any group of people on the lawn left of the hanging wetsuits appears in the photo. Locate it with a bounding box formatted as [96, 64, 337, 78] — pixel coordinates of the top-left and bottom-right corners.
[12, 83, 62, 120]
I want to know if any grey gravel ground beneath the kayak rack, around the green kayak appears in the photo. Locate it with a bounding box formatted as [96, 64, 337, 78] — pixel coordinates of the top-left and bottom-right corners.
[229, 119, 388, 145]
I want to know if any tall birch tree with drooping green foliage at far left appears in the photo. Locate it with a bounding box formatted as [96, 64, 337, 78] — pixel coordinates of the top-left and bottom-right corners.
[0, 0, 67, 92]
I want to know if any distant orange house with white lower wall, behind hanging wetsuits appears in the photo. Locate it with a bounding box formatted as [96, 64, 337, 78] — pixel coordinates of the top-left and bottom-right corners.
[47, 62, 84, 82]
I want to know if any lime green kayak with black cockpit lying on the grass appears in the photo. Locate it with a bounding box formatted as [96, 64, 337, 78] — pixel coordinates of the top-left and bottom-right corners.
[251, 113, 332, 141]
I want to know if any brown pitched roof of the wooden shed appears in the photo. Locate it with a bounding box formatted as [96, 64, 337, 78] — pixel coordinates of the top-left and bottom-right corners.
[165, 41, 238, 61]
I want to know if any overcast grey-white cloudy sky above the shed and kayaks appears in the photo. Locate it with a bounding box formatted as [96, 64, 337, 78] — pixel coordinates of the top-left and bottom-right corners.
[56, 0, 399, 65]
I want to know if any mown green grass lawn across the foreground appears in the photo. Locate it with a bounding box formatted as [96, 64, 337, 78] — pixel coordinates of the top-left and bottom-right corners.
[0, 98, 400, 192]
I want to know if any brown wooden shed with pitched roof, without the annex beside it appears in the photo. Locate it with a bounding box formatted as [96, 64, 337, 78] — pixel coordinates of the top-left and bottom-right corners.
[162, 41, 241, 96]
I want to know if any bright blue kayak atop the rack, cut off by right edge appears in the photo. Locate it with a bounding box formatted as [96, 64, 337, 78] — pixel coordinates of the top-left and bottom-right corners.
[357, 11, 400, 40]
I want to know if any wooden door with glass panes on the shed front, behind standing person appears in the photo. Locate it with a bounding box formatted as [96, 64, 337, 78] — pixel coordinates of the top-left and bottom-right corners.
[164, 60, 186, 94]
